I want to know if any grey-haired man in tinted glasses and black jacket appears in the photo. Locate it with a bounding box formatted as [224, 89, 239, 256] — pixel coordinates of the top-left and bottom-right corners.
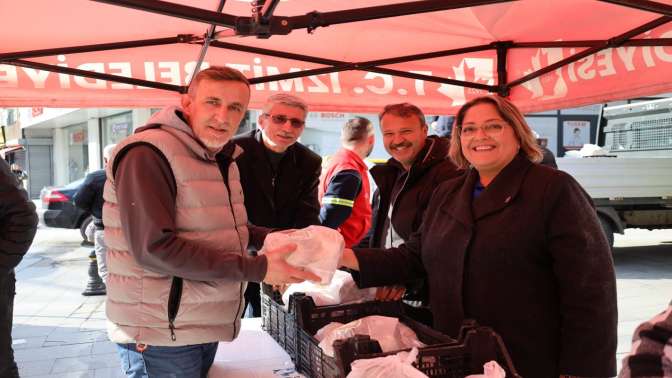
[234, 93, 322, 317]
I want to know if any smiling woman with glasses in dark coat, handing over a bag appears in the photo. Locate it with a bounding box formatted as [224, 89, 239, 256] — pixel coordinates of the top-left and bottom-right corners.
[342, 96, 617, 378]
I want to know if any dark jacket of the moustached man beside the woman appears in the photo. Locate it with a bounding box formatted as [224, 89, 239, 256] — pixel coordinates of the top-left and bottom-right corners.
[369, 136, 460, 248]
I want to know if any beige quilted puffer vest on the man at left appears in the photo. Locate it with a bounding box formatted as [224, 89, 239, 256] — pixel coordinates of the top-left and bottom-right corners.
[103, 126, 249, 346]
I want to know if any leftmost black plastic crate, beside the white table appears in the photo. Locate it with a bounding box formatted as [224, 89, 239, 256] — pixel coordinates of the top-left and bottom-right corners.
[261, 284, 298, 365]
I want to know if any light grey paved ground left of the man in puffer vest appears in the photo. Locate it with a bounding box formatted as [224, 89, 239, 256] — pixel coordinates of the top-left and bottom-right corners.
[12, 228, 123, 378]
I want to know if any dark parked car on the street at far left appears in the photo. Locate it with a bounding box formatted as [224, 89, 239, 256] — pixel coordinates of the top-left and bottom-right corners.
[38, 178, 92, 241]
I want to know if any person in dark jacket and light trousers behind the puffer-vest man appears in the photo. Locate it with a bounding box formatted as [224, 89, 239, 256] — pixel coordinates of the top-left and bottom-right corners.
[73, 144, 116, 283]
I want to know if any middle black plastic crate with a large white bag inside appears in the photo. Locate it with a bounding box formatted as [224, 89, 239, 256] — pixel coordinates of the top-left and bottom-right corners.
[290, 294, 460, 378]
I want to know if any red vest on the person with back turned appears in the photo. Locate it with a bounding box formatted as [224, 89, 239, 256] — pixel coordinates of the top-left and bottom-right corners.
[318, 148, 371, 248]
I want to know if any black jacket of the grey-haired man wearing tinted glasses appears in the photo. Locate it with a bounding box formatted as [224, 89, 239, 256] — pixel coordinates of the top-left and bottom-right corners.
[228, 130, 322, 229]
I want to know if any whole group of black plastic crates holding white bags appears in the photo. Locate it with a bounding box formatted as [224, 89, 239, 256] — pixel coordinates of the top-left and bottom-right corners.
[262, 287, 519, 378]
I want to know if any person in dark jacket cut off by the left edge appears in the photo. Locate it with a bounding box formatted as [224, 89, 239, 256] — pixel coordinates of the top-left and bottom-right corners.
[0, 159, 37, 378]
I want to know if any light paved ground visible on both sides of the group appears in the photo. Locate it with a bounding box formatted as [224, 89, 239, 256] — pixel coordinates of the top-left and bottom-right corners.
[13, 228, 672, 378]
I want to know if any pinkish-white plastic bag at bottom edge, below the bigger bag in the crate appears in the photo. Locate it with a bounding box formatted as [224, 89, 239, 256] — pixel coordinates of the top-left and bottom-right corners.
[347, 348, 427, 378]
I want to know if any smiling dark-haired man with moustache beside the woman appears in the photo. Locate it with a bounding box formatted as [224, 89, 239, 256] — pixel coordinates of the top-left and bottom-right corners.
[369, 103, 458, 322]
